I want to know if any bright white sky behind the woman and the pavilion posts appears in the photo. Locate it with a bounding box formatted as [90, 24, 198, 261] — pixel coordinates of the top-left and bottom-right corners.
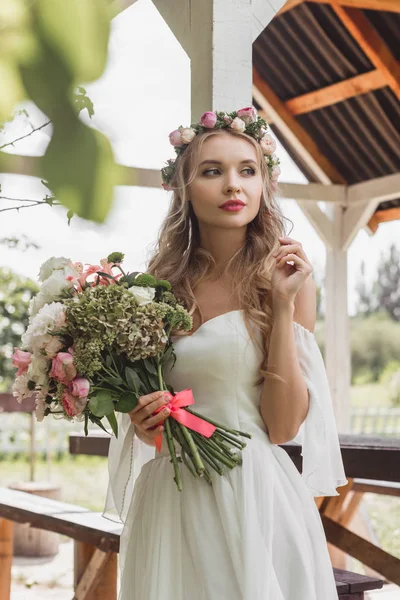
[0, 0, 400, 314]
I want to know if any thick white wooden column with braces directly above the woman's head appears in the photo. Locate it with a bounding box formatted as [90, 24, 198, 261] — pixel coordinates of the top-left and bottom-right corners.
[154, 0, 285, 120]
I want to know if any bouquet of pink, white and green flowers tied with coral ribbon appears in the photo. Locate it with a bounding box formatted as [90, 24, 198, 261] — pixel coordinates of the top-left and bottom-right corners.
[13, 252, 251, 491]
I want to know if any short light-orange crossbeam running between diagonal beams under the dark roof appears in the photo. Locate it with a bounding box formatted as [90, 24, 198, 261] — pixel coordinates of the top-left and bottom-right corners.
[285, 67, 392, 115]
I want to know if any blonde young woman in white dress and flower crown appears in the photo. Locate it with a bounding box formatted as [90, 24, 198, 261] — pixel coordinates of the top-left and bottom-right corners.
[106, 107, 347, 600]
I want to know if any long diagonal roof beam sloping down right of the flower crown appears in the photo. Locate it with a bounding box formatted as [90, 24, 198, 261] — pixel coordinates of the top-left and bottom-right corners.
[253, 66, 346, 185]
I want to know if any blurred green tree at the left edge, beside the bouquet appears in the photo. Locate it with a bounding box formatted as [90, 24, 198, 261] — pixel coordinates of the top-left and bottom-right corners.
[0, 267, 39, 392]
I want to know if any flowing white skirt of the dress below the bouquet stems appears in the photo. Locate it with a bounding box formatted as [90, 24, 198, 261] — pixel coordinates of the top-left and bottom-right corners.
[119, 432, 337, 600]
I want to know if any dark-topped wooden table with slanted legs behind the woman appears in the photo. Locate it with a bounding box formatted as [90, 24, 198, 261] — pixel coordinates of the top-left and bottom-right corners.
[69, 430, 400, 585]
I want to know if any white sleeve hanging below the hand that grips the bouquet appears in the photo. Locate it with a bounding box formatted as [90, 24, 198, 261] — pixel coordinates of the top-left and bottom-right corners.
[103, 413, 155, 523]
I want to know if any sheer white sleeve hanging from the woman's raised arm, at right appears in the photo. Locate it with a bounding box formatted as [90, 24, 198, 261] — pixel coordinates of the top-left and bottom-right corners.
[293, 322, 347, 496]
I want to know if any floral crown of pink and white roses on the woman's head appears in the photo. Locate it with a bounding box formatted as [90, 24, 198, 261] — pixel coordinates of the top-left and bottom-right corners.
[161, 106, 281, 191]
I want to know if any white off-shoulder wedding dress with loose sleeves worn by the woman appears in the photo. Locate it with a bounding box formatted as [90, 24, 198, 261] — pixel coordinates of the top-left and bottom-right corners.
[104, 310, 347, 600]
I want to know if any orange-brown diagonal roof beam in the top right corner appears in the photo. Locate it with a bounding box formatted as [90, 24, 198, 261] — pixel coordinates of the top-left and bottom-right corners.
[332, 4, 400, 99]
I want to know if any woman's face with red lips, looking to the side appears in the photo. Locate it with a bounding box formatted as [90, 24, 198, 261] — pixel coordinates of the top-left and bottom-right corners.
[188, 133, 263, 228]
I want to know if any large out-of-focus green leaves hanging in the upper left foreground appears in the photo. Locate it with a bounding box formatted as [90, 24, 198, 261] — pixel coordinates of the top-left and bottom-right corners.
[0, 0, 116, 222]
